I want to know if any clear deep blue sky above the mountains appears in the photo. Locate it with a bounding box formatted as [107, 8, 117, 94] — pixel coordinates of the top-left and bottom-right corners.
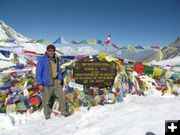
[0, 0, 180, 46]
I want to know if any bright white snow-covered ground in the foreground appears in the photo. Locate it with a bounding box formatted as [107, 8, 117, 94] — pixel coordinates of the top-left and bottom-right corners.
[0, 94, 180, 135]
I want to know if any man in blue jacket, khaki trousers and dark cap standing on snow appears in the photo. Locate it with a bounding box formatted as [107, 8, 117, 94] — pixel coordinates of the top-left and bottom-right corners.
[36, 45, 68, 119]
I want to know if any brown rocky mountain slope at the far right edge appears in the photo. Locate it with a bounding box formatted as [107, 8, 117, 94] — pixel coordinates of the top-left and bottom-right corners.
[162, 37, 180, 60]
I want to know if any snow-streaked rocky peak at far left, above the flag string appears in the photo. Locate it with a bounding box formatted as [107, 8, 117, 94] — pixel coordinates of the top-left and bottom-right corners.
[0, 20, 31, 41]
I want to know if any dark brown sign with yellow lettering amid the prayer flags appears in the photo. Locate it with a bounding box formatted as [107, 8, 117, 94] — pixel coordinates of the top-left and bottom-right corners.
[73, 61, 116, 88]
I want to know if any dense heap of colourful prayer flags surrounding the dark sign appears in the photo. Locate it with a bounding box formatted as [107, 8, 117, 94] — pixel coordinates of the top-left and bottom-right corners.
[0, 53, 180, 114]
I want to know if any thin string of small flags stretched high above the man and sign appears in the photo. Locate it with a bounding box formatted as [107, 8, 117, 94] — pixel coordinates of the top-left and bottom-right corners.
[0, 33, 180, 51]
